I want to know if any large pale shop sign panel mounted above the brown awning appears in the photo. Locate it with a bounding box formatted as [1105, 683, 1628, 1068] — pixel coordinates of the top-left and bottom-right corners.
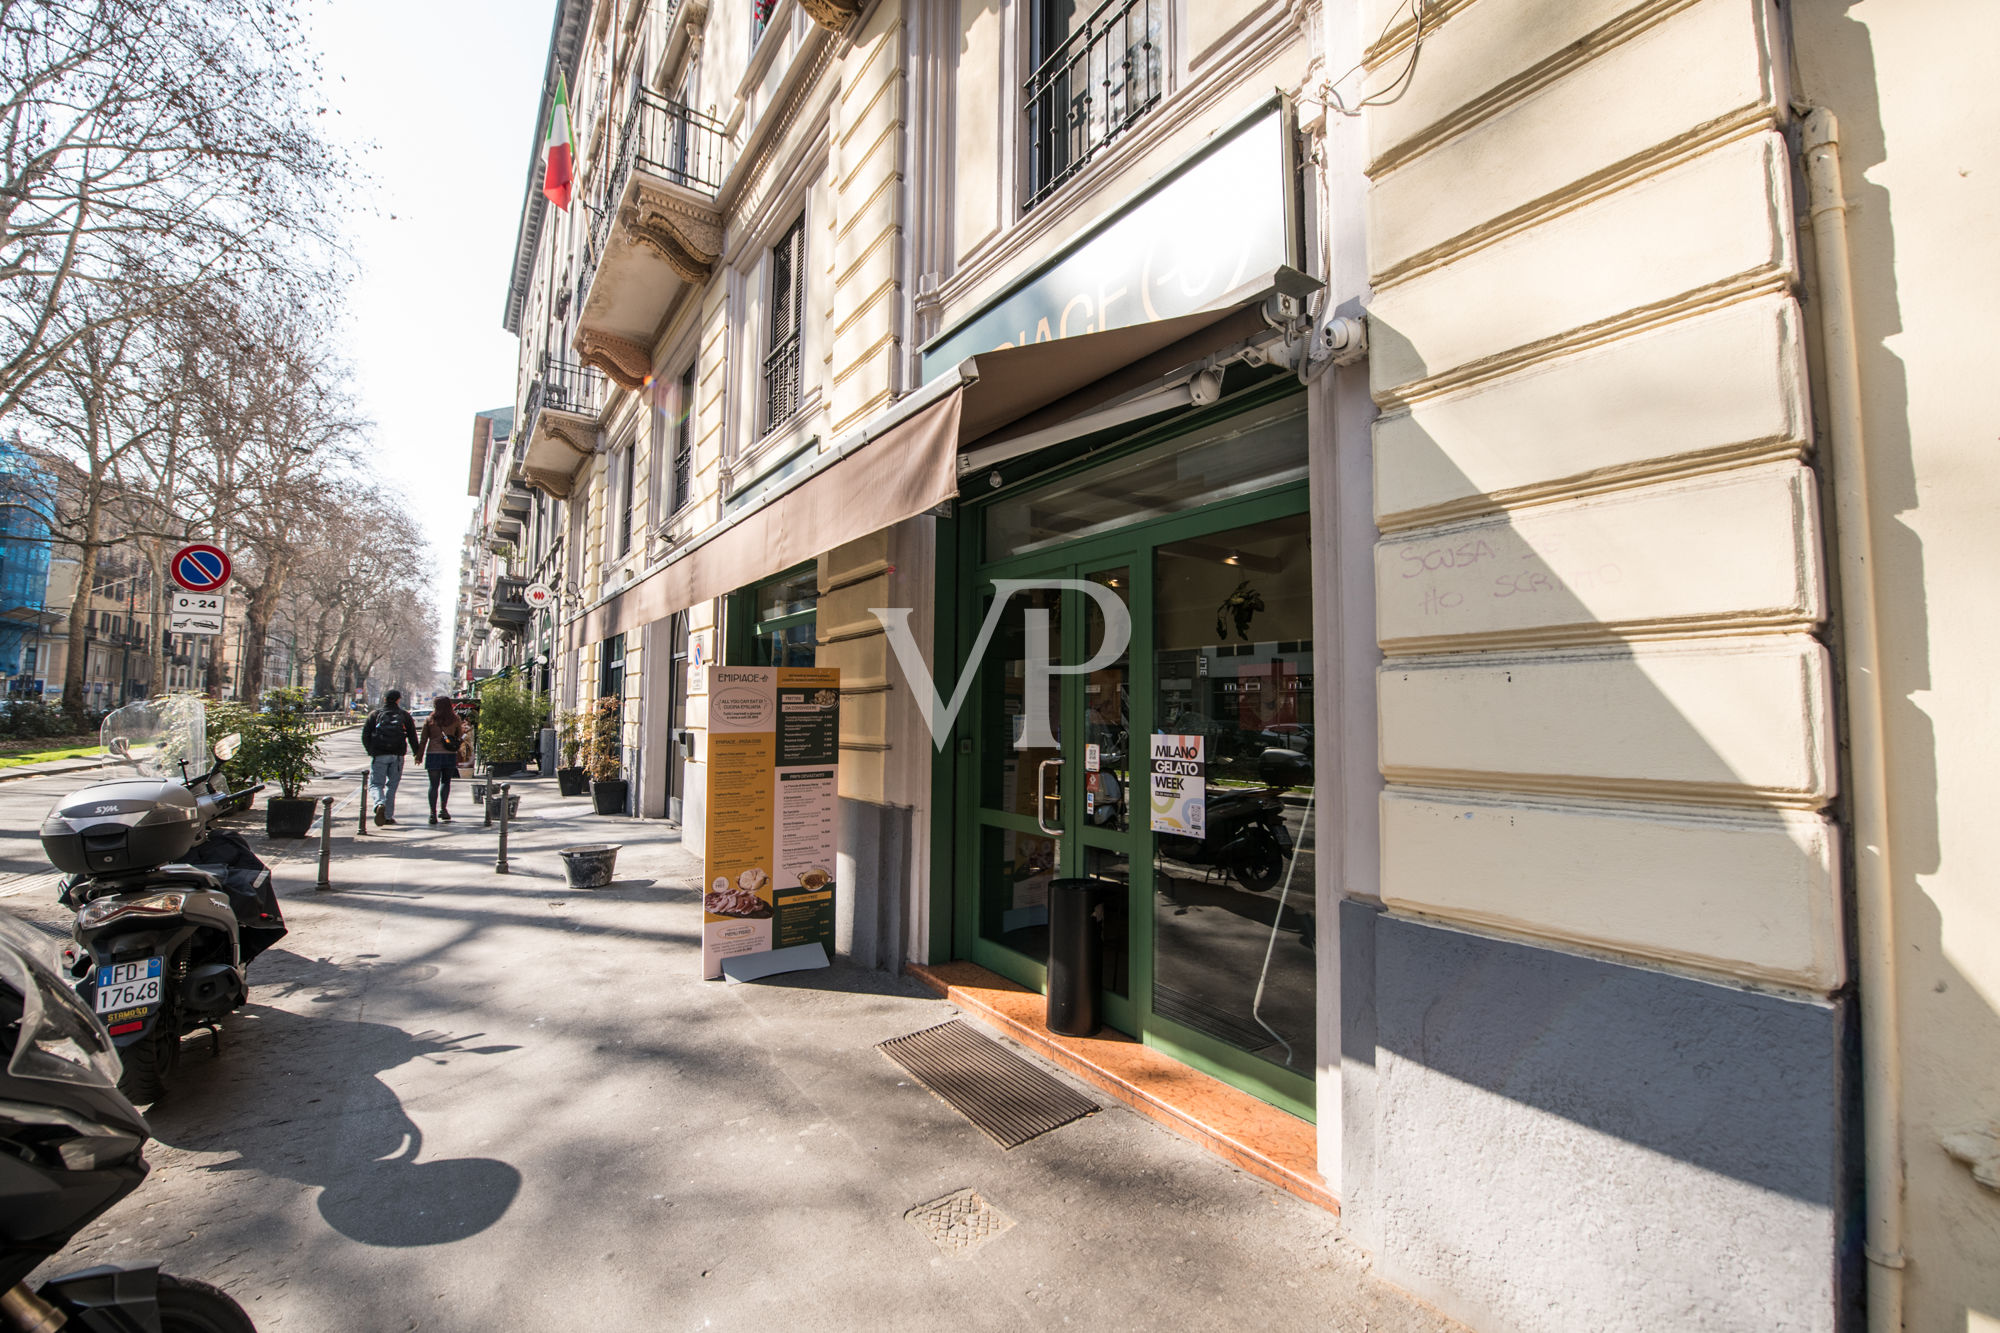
[924, 102, 1298, 380]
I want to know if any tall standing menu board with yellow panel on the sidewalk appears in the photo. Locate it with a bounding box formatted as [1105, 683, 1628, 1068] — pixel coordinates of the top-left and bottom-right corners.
[702, 667, 840, 981]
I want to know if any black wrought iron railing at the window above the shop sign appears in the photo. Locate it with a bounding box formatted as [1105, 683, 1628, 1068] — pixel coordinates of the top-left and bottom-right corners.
[1022, 0, 1166, 208]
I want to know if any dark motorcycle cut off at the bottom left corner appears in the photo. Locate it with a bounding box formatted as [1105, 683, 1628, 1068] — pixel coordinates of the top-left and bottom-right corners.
[0, 913, 256, 1333]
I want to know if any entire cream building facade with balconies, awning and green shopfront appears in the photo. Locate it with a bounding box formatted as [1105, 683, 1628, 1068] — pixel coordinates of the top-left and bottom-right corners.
[488, 0, 2000, 1333]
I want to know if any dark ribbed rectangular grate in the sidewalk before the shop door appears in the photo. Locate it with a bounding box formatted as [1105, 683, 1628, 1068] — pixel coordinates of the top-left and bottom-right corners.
[876, 1019, 1098, 1149]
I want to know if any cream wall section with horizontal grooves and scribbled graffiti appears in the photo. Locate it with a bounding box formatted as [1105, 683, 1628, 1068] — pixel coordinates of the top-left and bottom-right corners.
[1362, 0, 1846, 995]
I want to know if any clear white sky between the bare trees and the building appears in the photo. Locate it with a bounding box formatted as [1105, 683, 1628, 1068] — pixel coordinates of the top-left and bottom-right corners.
[300, 0, 556, 664]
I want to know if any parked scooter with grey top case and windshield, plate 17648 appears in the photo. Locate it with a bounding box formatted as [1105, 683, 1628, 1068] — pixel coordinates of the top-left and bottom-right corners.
[42, 699, 284, 1103]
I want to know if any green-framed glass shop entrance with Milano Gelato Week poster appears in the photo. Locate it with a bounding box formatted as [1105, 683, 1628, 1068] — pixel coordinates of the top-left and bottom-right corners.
[946, 394, 1316, 1119]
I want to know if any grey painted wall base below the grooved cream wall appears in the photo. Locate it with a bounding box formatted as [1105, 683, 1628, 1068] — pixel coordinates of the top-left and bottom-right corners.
[1342, 915, 1858, 1333]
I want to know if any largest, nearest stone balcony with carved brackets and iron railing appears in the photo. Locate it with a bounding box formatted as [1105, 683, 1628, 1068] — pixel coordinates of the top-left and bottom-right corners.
[576, 90, 728, 388]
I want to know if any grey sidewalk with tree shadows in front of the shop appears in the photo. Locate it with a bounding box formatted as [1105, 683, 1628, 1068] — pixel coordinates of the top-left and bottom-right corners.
[4, 737, 1456, 1333]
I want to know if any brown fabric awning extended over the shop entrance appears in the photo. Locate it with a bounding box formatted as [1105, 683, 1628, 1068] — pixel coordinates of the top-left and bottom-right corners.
[570, 268, 1320, 646]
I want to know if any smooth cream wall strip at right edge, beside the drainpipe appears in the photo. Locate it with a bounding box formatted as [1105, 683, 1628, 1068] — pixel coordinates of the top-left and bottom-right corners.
[1792, 0, 2000, 1333]
